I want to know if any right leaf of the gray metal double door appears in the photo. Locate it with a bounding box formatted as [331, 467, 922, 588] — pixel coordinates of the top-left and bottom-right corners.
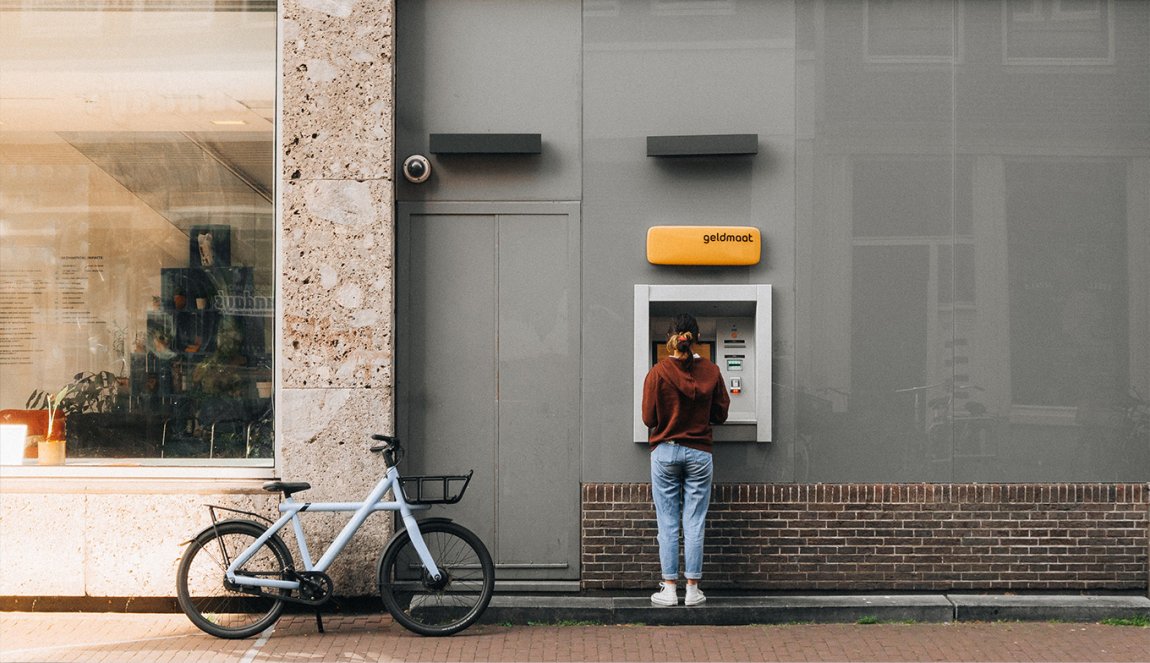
[498, 210, 583, 569]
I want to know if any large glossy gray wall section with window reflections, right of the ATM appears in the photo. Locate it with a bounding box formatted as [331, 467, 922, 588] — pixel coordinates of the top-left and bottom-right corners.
[796, 0, 1150, 481]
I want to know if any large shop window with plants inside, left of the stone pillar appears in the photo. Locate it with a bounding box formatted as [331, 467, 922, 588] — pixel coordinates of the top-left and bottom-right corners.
[0, 0, 276, 465]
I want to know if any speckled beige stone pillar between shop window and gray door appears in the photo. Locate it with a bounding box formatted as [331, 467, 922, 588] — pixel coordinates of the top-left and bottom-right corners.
[277, 0, 394, 595]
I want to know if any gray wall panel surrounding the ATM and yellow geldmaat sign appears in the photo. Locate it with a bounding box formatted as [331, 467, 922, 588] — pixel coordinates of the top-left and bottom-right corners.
[583, 2, 796, 481]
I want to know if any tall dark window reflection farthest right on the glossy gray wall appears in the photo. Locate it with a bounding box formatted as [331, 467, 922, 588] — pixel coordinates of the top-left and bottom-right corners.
[1006, 162, 1129, 408]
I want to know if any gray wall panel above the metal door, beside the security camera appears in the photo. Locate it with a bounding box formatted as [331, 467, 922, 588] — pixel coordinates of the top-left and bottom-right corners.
[396, 0, 581, 200]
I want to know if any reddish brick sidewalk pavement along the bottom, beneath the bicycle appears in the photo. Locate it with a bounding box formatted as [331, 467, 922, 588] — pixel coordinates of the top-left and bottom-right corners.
[0, 612, 1150, 663]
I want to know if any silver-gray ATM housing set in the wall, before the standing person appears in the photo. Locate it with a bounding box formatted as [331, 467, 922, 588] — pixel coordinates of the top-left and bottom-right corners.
[633, 284, 772, 442]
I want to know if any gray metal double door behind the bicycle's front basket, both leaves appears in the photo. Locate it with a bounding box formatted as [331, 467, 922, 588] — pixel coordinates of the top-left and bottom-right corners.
[396, 202, 582, 580]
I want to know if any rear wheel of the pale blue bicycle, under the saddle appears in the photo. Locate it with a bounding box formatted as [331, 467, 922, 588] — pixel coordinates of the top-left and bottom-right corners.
[176, 521, 292, 639]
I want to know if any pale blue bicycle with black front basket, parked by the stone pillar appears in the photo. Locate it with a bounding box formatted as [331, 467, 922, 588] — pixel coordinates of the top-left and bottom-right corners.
[176, 434, 495, 638]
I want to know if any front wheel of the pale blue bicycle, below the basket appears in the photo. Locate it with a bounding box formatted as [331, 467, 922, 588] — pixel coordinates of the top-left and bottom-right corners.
[380, 521, 496, 635]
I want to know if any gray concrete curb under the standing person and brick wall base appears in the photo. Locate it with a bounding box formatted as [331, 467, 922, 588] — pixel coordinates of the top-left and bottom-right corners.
[482, 594, 1150, 626]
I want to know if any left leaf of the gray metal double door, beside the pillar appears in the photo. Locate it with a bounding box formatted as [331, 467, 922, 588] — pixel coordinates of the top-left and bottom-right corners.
[397, 208, 498, 541]
